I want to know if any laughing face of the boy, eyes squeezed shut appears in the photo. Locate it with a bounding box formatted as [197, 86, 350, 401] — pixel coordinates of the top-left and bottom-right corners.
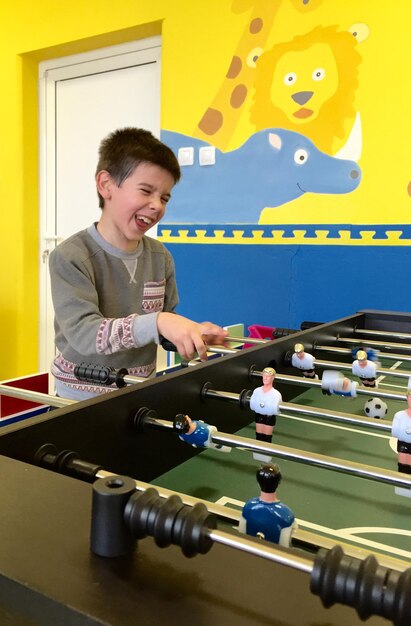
[97, 163, 174, 251]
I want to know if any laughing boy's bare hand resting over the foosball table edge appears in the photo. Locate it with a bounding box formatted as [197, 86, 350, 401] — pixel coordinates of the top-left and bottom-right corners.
[157, 312, 228, 361]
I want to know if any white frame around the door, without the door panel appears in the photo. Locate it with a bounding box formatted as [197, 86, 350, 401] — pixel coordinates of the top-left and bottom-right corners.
[38, 35, 161, 371]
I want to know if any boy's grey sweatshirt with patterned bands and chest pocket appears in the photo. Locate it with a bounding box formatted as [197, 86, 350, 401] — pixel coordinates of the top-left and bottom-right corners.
[50, 224, 178, 400]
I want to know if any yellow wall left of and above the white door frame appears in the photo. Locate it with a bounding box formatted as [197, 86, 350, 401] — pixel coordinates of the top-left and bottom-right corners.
[0, 0, 183, 379]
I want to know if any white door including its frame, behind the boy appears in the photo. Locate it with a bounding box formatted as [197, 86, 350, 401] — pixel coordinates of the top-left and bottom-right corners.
[39, 37, 161, 380]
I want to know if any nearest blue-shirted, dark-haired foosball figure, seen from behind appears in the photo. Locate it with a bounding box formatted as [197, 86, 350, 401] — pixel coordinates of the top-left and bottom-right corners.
[238, 463, 297, 547]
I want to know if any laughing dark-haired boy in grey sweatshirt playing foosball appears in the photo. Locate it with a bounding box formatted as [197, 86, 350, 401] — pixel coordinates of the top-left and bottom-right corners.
[50, 128, 227, 400]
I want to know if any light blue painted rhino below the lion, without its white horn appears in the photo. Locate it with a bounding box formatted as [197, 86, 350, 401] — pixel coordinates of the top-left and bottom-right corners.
[161, 128, 361, 224]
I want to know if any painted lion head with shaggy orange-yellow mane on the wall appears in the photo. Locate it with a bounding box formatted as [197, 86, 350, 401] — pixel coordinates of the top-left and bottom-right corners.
[250, 25, 368, 154]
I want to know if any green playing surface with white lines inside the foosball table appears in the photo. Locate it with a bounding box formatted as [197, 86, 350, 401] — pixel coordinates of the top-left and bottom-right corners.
[154, 361, 411, 561]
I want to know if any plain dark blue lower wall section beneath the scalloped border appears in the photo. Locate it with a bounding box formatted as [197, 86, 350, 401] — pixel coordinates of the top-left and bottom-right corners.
[165, 243, 411, 328]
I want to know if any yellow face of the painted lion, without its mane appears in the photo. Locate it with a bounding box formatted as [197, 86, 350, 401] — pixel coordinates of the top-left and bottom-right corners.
[270, 43, 338, 126]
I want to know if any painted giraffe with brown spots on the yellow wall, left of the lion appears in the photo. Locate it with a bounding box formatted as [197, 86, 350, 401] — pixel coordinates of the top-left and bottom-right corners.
[193, 0, 322, 150]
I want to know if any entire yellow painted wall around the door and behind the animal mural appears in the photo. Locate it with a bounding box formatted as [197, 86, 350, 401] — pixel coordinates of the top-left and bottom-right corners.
[0, 0, 411, 378]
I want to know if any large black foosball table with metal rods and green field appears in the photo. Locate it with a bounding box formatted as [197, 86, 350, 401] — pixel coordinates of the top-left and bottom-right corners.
[0, 311, 411, 626]
